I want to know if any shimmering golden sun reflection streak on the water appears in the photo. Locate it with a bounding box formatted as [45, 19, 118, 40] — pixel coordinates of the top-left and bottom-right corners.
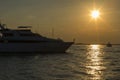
[86, 45, 105, 80]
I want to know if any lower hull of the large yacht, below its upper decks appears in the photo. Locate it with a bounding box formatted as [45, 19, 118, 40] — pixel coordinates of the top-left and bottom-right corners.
[0, 42, 73, 53]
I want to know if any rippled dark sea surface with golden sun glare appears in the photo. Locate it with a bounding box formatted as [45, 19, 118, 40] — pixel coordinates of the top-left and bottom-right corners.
[0, 45, 120, 80]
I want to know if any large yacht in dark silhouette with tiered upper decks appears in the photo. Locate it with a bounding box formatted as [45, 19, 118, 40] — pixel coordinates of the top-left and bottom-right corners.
[0, 24, 73, 53]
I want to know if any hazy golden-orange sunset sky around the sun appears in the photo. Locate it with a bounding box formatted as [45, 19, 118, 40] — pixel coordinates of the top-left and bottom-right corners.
[0, 0, 120, 43]
